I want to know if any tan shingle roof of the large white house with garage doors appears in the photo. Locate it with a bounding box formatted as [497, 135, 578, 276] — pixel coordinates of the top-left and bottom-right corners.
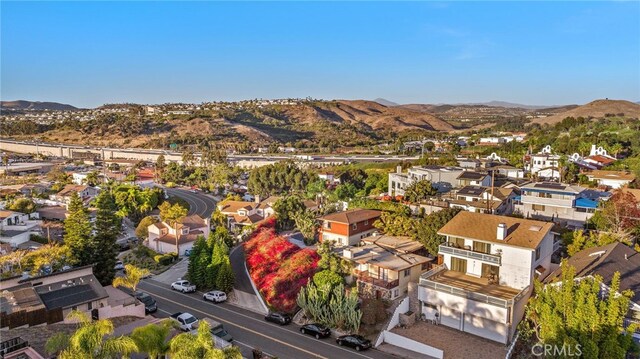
[438, 211, 553, 249]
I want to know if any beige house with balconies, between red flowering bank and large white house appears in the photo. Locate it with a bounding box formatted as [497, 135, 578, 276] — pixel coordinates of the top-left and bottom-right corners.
[342, 236, 433, 300]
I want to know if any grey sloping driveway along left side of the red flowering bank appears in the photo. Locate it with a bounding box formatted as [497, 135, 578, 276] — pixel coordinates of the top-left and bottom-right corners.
[229, 245, 267, 314]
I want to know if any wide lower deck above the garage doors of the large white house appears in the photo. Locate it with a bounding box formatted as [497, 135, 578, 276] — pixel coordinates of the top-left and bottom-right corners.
[420, 265, 529, 308]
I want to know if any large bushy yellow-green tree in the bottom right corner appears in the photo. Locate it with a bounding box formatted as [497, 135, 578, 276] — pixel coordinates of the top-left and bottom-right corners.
[520, 261, 635, 358]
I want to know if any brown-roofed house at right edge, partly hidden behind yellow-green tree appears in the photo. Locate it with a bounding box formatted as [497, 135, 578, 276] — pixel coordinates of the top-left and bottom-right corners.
[545, 242, 640, 342]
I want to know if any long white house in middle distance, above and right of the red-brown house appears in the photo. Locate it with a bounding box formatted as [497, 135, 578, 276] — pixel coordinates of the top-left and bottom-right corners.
[389, 166, 464, 196]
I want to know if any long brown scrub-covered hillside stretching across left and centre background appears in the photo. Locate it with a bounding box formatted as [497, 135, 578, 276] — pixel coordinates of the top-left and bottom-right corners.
[5, 100, 454, 148]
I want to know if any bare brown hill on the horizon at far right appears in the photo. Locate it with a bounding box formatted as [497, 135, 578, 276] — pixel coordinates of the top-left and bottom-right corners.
[531, 99, 640, 125]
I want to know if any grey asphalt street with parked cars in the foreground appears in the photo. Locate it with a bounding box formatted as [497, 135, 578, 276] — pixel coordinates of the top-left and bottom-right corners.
[138, 279, 397, 359]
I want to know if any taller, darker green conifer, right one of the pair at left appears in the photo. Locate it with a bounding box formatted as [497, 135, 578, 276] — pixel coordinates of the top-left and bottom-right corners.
[92, 191, 122, 285]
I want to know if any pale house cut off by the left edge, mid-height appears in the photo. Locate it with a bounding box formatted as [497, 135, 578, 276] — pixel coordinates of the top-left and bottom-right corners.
[0, 210, 42, 248]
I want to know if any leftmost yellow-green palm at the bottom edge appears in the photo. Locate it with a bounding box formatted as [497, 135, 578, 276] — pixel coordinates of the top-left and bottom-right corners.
[45, 310, 138, 359]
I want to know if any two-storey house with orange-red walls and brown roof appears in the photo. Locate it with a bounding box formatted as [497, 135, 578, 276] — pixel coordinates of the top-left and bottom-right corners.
[318, 208, 382, 247]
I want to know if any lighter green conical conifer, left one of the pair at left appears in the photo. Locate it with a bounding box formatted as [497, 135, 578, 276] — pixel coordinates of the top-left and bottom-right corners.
[64, 193, 93, 266]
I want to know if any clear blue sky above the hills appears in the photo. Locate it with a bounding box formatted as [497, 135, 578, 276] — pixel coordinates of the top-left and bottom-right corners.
[0, 1, 640, 107]
